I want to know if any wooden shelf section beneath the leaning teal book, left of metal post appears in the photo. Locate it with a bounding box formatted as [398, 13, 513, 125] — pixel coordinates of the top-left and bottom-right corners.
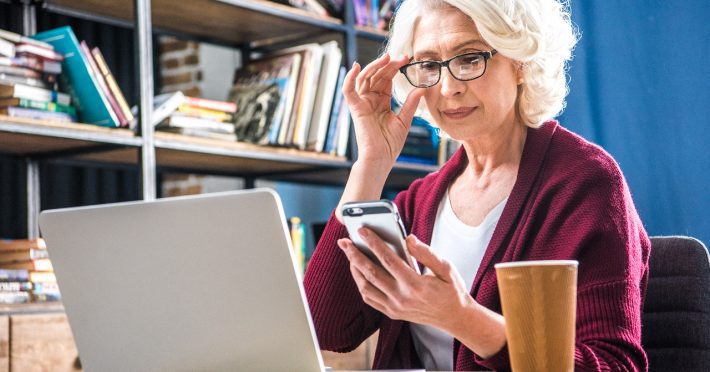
[0, 115, 142, 157]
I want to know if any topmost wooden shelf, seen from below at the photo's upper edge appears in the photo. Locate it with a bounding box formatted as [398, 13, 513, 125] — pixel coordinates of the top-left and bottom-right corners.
[45, 0, 345, 44]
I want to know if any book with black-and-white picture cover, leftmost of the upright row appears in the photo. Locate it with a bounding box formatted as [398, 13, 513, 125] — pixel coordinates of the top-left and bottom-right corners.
[229, 53, 301, 144]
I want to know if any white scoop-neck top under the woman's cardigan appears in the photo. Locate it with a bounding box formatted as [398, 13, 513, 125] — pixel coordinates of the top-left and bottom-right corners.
[410, 190, 508, 371]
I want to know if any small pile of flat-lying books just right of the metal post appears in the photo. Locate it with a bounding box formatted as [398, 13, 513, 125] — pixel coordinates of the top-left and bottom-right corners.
[152, 91, 237, 141]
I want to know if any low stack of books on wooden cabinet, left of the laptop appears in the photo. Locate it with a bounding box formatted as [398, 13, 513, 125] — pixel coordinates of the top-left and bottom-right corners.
[0, 239, 61, 304]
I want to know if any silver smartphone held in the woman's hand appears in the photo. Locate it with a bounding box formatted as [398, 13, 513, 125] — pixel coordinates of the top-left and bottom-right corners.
[342, 199, 420, 274]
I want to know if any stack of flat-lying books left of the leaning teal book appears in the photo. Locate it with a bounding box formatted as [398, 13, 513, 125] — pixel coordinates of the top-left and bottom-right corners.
[0, 30, 77, 122]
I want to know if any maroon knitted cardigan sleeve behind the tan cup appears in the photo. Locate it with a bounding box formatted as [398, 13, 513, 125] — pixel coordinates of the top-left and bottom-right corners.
[475, 147, 650, 371]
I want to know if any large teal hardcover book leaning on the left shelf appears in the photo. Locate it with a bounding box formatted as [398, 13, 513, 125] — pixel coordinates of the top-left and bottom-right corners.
[33, 26, 119, 127]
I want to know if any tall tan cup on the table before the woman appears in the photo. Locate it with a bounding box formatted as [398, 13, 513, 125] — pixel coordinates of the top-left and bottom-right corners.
[495, 260, 578, 372]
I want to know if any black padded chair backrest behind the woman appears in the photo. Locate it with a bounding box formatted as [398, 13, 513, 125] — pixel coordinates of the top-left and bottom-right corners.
[642, 236, 710, 371]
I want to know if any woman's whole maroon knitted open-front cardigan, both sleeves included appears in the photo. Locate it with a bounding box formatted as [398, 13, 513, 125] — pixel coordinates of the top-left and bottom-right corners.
[305, 121, 650, 371]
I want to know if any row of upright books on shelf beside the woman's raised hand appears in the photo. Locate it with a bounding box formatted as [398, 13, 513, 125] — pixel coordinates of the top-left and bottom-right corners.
[228, 41, 349, 156]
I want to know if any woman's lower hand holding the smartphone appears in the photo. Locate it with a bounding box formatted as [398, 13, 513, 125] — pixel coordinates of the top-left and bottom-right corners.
[338, 228, 477, 330]
